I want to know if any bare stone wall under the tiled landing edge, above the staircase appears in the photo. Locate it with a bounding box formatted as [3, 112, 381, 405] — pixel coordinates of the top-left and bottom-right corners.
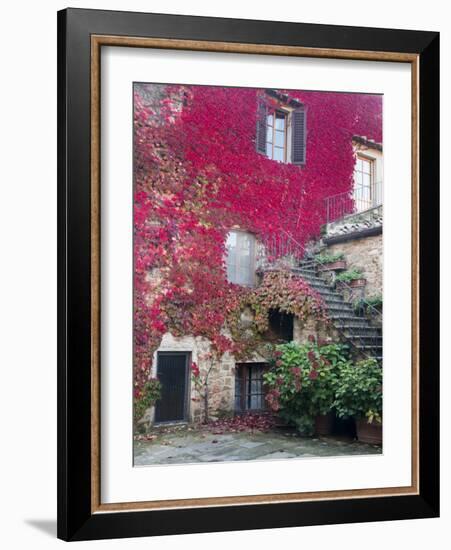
[323, 234, 383, 297]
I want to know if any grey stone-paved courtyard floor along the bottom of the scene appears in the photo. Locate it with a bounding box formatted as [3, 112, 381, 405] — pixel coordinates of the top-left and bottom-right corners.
[134, 431, 382, 466]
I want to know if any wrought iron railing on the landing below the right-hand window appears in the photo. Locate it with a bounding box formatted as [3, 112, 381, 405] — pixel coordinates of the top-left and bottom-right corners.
[324, 181, 382, 223]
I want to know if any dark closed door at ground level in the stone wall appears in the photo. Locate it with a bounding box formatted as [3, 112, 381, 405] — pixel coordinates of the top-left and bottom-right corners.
[155, 352, 189, 422]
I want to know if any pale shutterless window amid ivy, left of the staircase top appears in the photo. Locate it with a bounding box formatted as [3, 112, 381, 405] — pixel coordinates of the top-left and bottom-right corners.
[226, 231, 255, 286]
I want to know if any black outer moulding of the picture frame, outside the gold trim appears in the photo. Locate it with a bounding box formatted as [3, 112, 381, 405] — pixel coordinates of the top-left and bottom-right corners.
[58, 9, 439, 541]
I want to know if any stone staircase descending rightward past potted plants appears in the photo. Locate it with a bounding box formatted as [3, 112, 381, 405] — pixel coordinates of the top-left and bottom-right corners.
[292, 261, 382, 362]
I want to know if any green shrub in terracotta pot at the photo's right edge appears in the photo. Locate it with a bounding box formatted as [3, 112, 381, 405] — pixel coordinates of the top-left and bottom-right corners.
[334, 359, 382, 444]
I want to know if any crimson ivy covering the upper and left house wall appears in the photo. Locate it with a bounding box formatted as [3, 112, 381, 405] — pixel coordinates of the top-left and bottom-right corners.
[134, 85, 382, 398]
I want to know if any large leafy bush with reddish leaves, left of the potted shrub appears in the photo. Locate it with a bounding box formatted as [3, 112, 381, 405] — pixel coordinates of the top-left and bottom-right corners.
[264, 337, 348, 435]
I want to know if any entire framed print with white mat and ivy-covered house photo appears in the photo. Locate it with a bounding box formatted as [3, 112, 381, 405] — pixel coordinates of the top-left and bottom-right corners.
[58, 9, 439, 540]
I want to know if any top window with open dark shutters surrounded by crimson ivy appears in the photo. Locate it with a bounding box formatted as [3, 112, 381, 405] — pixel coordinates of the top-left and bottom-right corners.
[256, 91, 307, 164]
